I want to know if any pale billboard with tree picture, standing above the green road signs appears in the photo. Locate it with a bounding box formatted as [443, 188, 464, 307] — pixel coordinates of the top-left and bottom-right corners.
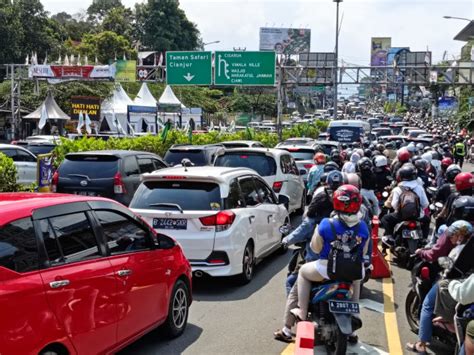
[260, 27, 311, 54]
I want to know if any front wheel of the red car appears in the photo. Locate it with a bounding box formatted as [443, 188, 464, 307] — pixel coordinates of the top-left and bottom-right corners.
[163, 280, 189, 338]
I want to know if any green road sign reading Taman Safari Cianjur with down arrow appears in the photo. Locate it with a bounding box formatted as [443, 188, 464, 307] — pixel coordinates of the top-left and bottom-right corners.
[166, 52, 212, 85]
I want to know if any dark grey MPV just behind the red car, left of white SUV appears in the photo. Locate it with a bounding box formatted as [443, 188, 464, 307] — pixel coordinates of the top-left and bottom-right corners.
[52, 150, 167, 206]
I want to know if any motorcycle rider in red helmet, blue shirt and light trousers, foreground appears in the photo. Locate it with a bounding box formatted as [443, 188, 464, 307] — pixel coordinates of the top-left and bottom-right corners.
[291, 185, 369, 320]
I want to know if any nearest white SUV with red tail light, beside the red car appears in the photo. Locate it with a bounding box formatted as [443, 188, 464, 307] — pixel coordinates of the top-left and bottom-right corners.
[130, 167, 289, 283]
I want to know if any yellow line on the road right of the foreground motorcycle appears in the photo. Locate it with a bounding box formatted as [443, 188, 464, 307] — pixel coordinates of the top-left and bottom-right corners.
[382, 251, 403, 354]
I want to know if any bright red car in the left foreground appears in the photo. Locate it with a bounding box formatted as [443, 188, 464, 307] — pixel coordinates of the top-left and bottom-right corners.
[0, 193, 192, 355]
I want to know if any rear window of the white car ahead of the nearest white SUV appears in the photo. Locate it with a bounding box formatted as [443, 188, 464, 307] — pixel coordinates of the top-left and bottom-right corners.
[214, 152, 276, 176]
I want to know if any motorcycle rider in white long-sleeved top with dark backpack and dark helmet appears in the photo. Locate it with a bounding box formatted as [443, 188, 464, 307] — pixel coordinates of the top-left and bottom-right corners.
[381, 163, 430, 246]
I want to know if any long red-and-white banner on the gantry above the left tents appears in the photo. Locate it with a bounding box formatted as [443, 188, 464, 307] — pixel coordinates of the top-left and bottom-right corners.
[28, 65, 115, 80]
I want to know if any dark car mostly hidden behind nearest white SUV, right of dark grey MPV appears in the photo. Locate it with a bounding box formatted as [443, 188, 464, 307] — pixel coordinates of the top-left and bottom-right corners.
[164, 144, 224, 166]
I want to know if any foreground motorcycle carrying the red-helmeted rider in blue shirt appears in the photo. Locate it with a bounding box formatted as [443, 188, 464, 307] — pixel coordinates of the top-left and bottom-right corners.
[308, 280, 362, 355]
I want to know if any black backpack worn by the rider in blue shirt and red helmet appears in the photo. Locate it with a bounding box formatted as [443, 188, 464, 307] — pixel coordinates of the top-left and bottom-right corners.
[328, 218, 363, 282]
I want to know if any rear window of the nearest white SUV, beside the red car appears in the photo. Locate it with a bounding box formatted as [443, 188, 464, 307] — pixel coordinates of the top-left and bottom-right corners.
[130, 180, 222, 211]
